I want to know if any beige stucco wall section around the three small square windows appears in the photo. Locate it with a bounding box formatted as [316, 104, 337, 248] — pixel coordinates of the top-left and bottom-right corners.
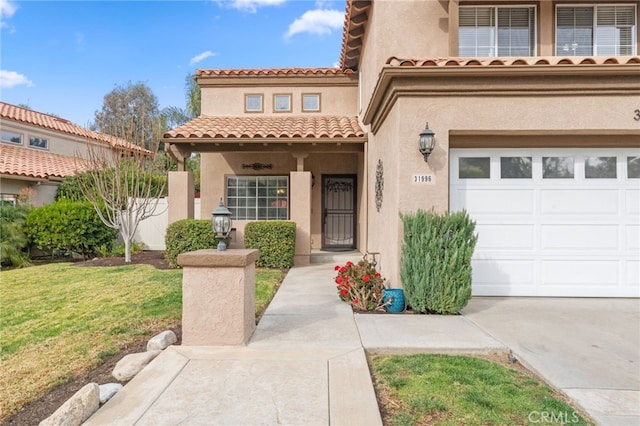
[202, 82, 358, 117]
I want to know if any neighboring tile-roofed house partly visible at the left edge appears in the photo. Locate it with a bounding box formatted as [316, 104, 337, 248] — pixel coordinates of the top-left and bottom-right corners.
[0, 102, 130, 207]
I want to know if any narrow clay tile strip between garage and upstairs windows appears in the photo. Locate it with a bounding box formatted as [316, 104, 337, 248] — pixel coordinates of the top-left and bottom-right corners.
[387, 56, 640, 67]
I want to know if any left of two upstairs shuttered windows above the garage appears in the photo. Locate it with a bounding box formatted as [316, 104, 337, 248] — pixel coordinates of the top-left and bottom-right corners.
[458, 6, 536, 57]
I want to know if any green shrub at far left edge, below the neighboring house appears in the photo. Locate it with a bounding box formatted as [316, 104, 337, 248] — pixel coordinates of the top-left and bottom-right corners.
[0, 202, 29, 267]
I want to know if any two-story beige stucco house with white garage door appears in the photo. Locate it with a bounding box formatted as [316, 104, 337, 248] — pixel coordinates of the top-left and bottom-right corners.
[164, 0, 640, 297]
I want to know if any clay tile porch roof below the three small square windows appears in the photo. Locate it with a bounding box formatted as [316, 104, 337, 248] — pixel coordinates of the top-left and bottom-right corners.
[164, 115, 365, 139]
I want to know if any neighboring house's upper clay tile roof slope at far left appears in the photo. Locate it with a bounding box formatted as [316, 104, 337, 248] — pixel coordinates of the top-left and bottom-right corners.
[0, 102, 140, 149]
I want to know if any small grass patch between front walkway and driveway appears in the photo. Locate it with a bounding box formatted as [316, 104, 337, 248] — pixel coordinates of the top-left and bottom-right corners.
[370, 354, 590, 426]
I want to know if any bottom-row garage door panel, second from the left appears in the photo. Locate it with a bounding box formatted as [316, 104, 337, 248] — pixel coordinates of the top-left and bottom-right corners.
[540, 259, 620, 288]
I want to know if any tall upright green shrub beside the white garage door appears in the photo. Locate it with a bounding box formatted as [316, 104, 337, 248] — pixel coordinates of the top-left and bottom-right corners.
[400, 210, 478, 314]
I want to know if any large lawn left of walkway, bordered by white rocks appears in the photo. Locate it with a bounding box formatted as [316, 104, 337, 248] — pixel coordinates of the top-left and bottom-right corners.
[0, 263, 284, 420]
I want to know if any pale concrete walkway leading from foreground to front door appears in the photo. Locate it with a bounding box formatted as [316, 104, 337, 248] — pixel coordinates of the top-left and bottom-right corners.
[86, 258, 382, 425]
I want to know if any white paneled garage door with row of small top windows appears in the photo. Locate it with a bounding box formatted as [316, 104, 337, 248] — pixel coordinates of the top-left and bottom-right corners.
[450, 148, 640, 297]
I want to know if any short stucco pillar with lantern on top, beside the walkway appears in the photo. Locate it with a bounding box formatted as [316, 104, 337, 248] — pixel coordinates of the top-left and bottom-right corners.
[178, 249, 259, 346]
